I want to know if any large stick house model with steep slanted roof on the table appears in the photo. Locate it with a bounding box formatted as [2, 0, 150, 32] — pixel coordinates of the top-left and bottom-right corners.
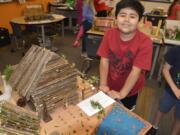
[9, 45, 79, 112]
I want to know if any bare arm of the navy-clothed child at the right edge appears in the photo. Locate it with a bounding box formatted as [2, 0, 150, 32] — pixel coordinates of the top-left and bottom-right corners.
[163, 62, 180, 99]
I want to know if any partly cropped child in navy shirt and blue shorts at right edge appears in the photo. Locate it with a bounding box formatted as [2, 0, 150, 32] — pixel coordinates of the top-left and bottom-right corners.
[148, 46, 180, 135]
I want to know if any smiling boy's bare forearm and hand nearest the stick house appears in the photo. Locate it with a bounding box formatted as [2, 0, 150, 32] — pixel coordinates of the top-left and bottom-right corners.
[99, 57, 109, 93]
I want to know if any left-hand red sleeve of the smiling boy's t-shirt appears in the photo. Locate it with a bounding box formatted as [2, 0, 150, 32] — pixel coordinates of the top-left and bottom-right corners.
[97, 31, 109, 58]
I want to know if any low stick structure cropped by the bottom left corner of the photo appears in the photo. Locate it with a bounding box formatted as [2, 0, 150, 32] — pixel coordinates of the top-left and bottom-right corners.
[0, 101, 40, 135]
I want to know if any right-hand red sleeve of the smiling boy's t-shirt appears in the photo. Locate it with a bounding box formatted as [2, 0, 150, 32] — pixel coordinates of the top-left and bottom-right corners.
[133, 38, 152, 70]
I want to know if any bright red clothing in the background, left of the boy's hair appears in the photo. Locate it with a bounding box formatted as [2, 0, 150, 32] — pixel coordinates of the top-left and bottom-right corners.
[94, 0, 111, 12]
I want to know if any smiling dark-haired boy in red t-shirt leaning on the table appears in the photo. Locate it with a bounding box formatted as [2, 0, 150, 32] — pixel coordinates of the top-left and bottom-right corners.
[97, 0, 152, 109]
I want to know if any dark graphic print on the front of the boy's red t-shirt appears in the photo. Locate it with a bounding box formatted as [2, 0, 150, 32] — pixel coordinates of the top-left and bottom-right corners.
[109, 49, 133, 80]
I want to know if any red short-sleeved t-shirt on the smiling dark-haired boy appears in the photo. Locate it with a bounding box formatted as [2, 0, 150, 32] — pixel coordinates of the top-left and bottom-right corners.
[97, 28, 152, 96]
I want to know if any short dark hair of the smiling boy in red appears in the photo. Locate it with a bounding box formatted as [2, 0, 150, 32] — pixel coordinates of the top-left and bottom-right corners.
[115, 0, 144, 20]
